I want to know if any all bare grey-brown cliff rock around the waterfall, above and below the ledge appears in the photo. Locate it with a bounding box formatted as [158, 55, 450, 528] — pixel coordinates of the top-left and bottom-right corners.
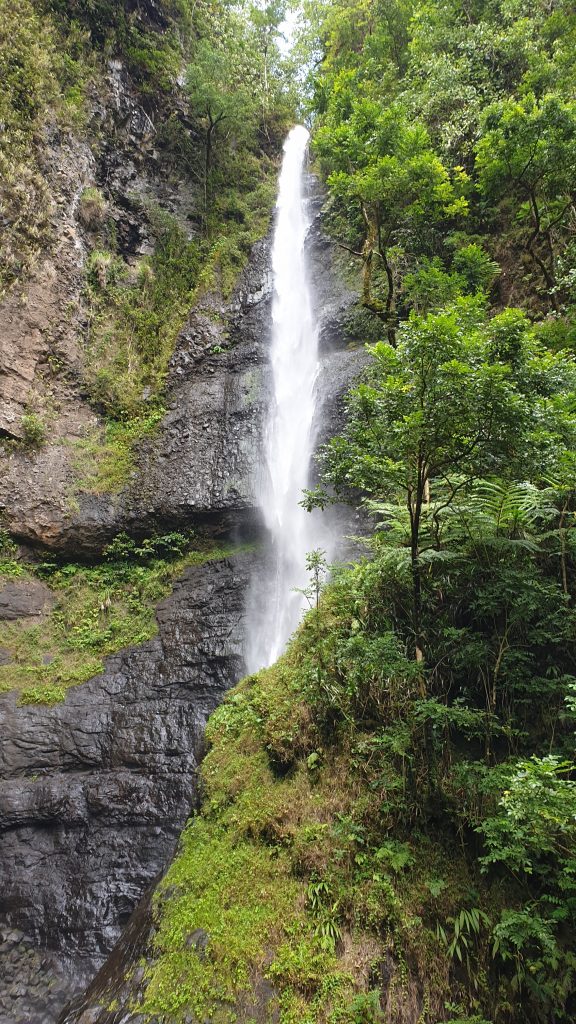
[0, 94, 362, 1024]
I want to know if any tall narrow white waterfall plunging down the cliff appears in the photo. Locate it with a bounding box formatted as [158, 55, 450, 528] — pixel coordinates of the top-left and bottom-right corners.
[246, 125, 319, 672]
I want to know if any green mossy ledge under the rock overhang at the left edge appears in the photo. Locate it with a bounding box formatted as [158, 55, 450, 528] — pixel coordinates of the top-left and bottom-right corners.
[0, 535, 238, 703]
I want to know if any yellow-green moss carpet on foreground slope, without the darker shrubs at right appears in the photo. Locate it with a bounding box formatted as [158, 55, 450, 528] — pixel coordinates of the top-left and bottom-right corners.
[137, 663, 385, 1024]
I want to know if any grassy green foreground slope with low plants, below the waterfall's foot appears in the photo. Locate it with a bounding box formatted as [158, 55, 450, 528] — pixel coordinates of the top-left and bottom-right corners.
[138, 598, 515, 1024]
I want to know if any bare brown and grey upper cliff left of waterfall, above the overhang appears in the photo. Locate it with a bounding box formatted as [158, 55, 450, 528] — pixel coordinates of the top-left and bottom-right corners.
[0, 41, 268, 554]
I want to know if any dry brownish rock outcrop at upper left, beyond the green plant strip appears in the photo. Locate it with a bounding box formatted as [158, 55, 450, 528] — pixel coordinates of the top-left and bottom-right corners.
[0, 51, 203, 553]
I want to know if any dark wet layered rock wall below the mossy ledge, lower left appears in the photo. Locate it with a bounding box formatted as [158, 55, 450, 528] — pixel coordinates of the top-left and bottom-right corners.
[0, 556, 248, 1024]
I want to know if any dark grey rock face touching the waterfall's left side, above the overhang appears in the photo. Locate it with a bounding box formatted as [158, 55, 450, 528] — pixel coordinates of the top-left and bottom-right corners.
[123, 240, 272, 531]
